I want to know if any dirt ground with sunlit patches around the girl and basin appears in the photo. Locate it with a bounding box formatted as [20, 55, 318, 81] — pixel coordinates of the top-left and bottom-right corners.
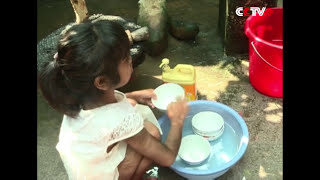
[37, 0, 283, 180]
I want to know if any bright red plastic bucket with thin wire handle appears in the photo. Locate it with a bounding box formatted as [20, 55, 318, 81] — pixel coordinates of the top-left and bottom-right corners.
[244, 8, 283, 98]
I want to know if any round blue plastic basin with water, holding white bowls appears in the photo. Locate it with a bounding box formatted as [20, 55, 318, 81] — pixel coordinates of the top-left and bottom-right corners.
[159, 100, 249, 180]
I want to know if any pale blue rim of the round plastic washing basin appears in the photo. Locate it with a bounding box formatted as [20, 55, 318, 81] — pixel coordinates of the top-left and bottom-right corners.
[158, 100, 250, 176]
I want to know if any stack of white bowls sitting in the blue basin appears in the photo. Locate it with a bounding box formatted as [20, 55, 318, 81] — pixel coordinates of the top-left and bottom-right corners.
[191, 111, 224, 141]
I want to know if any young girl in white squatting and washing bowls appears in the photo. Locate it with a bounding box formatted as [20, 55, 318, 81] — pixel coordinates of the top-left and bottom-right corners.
[39, 20, 188, 180]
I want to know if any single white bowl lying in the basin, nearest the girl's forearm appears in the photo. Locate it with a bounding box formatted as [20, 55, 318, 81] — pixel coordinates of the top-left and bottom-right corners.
[178, 134, 211, 165]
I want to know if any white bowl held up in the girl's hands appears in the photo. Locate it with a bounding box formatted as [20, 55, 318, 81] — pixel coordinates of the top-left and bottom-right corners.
[151, 83, 184, 111]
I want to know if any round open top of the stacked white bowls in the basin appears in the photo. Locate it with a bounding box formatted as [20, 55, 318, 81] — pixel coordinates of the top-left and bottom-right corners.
[192, 111, 224, 133]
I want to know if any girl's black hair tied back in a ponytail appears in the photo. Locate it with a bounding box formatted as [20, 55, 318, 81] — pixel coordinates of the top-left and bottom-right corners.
[39, 20, 130, 117]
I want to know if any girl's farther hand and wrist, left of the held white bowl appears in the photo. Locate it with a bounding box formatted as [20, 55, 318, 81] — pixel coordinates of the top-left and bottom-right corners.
[126, 89, 157, 108]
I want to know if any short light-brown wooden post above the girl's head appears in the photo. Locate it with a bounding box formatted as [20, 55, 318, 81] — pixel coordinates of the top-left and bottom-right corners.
[70, 0, 89, 24]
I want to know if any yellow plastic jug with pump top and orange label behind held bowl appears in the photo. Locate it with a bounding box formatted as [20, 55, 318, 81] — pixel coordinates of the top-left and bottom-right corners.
[159, 58, 197, 101]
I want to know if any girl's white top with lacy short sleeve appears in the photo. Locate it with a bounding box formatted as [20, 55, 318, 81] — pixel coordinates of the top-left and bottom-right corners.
[56, 91, 143, 180]
